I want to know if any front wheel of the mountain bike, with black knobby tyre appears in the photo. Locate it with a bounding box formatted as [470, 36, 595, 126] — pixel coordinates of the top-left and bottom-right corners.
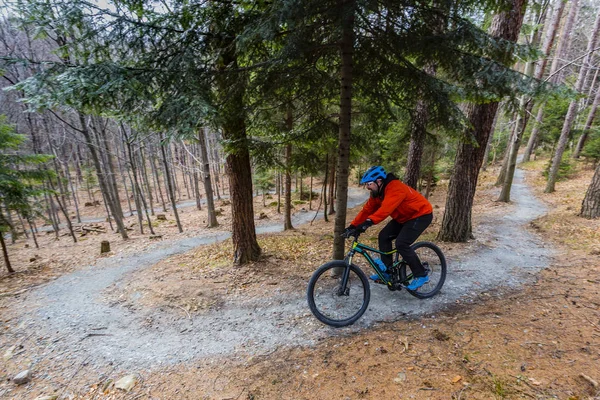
[306, 261, 371, 328]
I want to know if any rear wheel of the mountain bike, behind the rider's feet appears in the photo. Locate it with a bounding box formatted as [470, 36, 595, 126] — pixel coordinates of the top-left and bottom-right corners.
[400, 242, 446, 299]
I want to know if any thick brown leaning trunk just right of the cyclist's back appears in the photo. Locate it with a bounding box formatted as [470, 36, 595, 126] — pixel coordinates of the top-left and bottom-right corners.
[438, 0, 526, 242]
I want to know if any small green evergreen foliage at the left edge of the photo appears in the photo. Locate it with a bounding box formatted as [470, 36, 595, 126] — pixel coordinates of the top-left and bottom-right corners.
[0, 116, 53, 231]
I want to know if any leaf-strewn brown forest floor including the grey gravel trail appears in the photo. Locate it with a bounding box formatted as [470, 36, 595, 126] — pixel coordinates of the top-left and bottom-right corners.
[0, 161, 600, 400]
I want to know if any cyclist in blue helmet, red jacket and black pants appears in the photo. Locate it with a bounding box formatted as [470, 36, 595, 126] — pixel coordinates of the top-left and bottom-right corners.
[344, 166, 433, 290]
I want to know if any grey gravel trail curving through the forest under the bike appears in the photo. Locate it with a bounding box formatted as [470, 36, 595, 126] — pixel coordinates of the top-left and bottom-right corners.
[20, 170, 549, 370]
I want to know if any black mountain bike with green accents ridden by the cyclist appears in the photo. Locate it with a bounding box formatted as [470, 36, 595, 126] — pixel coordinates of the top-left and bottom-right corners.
[307, 232, 446, 327]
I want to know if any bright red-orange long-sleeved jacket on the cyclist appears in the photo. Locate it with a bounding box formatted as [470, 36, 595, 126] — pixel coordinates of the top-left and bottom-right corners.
[352, 179, 433, 226]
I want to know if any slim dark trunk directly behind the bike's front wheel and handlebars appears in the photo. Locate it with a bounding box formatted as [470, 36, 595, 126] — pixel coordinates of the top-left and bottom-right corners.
[333, 0, 356, 260]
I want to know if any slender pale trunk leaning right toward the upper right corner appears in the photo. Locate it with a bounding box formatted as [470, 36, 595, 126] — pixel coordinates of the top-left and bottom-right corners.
[544, 13, 600, 193]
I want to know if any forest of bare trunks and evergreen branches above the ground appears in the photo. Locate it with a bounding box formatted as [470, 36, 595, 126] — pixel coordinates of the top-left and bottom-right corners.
[0, 0, 600, 272]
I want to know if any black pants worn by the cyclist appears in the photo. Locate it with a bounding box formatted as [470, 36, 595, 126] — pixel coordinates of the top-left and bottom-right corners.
[379, 214, 433, 277]
